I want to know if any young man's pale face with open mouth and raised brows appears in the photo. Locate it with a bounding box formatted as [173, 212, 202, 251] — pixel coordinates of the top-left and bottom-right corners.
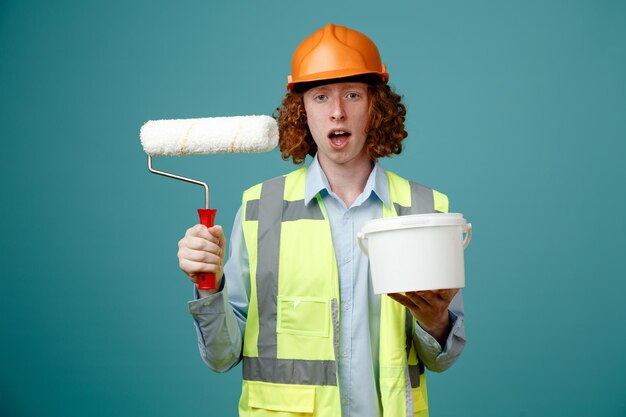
[304, 82, 371, 169]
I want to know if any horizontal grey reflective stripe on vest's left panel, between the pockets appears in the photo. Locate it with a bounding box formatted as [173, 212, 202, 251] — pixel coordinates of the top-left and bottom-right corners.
[243, 356, 337, 386]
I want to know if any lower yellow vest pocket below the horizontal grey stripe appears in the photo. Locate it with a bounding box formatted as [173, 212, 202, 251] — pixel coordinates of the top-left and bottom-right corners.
[248, 381, 315, 415]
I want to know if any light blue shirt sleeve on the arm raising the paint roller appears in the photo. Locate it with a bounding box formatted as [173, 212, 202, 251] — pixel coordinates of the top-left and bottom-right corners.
[188, 208, 250, 372]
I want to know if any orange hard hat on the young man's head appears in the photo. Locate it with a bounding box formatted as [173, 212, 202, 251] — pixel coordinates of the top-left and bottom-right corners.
[287, 23, 389, 91]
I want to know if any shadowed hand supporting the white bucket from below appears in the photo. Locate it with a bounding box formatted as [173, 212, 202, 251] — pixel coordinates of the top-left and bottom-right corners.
[388, 288, 459, 347]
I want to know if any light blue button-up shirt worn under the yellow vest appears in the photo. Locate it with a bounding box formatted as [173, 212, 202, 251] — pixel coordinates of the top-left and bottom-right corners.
[189, 157, 465, 417]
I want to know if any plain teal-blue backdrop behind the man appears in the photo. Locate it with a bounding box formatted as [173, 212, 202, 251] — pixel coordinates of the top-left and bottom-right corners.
[0, 0, 626, 417]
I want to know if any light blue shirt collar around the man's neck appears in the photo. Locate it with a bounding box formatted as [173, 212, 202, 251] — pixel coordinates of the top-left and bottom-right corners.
[304, 155, 389, 206]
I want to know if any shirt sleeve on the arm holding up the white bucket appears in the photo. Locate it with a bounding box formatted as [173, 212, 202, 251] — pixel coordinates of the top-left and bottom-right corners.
[413, 291, 465, 372]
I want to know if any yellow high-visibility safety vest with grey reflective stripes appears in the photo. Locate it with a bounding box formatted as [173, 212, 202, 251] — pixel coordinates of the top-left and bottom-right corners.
[239, 168, 448, 417]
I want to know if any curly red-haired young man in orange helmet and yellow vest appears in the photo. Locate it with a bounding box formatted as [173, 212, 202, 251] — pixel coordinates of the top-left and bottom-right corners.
[178, 24, 465, 417]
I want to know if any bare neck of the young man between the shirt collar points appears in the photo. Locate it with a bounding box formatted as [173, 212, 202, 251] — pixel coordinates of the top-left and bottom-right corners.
[319, 159, 374, 207]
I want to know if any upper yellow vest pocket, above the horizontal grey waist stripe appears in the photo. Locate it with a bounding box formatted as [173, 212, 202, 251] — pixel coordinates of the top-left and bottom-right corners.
[276, 295, 330, 337]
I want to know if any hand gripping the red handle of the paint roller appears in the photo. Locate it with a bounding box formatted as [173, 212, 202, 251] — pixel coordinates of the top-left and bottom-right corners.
[178, 224, 226, 293]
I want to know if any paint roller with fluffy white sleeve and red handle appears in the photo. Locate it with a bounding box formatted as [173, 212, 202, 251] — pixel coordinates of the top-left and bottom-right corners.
[139, 116, 278, 290]
